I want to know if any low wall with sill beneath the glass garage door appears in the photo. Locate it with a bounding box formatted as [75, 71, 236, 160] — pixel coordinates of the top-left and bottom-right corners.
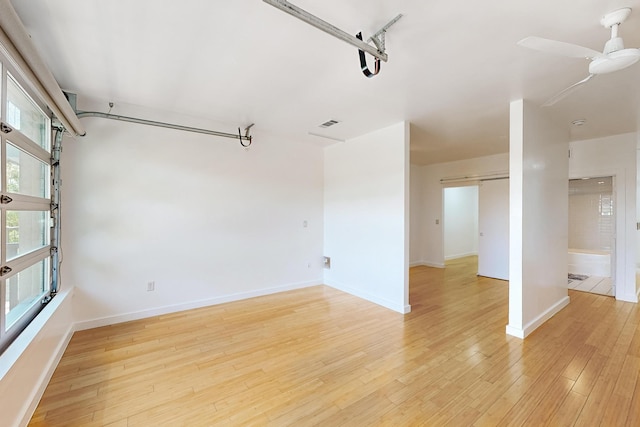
[0, 288, 75, 427]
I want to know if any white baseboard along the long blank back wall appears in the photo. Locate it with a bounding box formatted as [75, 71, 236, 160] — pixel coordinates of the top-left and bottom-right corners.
[75, 281, 322, 331]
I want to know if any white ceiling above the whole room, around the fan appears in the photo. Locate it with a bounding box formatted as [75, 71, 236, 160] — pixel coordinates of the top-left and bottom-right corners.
[13, 0, 640, 164]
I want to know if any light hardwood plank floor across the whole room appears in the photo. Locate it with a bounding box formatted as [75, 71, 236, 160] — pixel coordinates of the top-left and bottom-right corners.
[30, 258, 640, 426]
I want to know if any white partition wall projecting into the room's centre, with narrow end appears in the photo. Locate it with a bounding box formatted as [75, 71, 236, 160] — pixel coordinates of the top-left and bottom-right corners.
[324, 122, 410, 313]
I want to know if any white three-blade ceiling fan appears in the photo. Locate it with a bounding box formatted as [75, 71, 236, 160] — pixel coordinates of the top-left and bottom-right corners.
[518, 8, 640, 107]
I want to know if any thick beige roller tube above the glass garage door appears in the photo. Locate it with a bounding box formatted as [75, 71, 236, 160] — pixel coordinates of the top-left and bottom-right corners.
[0, 0, 86, 136]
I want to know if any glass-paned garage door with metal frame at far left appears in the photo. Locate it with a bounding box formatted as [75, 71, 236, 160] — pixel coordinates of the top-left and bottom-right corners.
[0, 54, 57, 351]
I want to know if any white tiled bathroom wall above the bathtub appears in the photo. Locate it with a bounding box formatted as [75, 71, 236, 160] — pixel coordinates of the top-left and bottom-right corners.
[569, 177, 615, 251]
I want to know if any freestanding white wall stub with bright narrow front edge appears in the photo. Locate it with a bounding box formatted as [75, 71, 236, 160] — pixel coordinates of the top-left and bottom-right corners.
[507, 100, 569, 338]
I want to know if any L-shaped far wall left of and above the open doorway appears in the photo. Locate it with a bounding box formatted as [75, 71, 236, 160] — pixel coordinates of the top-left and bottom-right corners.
[411, 153, 509, 267]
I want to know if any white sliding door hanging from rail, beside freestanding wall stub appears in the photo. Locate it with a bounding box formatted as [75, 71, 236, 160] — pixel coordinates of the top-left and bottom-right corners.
[478, 179, 509, 280]
